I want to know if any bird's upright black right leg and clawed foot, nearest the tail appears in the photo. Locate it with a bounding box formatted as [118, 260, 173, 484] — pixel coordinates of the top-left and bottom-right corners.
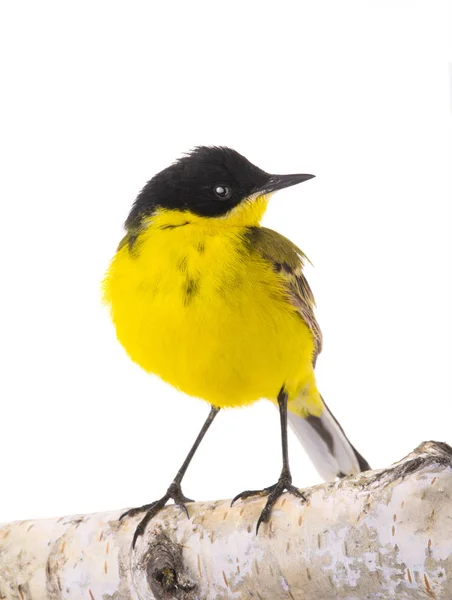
[231, 388, 306, 533]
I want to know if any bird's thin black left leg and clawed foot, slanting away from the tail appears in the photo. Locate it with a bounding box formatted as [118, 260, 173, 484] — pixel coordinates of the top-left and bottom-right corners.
[119, 406, 220, 548]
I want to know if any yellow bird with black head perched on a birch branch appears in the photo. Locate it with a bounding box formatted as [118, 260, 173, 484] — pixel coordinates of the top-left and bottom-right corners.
[103, 146, 370, 547]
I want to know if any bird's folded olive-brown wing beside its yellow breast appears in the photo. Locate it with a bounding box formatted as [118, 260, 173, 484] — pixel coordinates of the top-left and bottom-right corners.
[247, 227, 322, 366]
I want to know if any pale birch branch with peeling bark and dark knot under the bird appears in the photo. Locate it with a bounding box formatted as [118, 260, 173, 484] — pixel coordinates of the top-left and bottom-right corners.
[0, 442, 452, 600]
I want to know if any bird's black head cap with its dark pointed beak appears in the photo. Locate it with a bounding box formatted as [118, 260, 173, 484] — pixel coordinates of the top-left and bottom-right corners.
[125, 146, 313, 229]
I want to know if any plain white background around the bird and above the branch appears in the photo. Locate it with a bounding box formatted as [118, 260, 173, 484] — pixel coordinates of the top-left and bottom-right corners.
[0, 0, 452, 521]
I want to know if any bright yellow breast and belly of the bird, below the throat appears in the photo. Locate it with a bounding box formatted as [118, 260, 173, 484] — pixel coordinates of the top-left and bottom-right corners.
[104, 225, 318, 407]
